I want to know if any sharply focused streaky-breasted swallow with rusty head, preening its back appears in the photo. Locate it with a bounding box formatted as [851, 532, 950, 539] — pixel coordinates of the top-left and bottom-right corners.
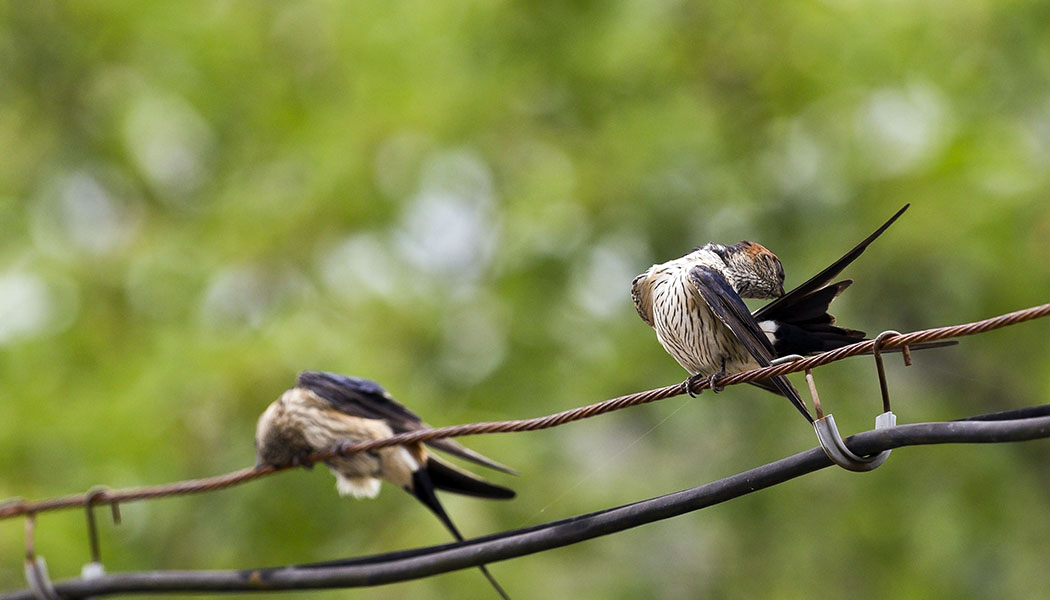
[631, 205, 909, 422]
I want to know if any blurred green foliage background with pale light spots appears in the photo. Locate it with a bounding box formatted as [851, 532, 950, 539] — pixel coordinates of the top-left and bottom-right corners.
[0, 0, 1050, 599]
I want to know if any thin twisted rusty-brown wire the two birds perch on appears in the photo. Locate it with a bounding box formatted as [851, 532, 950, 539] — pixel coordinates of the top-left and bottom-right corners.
[0, 304, 1050, 519]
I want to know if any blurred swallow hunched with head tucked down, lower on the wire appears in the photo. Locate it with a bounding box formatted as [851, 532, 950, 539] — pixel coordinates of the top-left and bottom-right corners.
[255, 371, 515, 598]
